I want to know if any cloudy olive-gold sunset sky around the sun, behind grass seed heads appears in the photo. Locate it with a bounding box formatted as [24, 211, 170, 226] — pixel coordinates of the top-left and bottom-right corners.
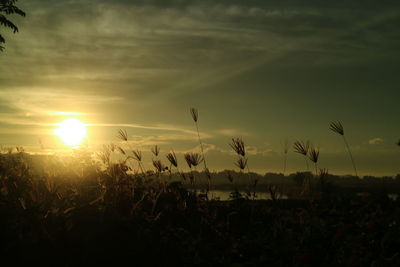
[0, 0, 400, 176]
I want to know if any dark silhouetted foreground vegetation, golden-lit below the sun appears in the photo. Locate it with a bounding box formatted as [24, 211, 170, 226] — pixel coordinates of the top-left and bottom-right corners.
[0, 152, 400, 266]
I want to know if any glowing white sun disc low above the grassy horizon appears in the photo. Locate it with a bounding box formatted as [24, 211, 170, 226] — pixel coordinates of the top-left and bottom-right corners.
[54, 118, 87, 148]
